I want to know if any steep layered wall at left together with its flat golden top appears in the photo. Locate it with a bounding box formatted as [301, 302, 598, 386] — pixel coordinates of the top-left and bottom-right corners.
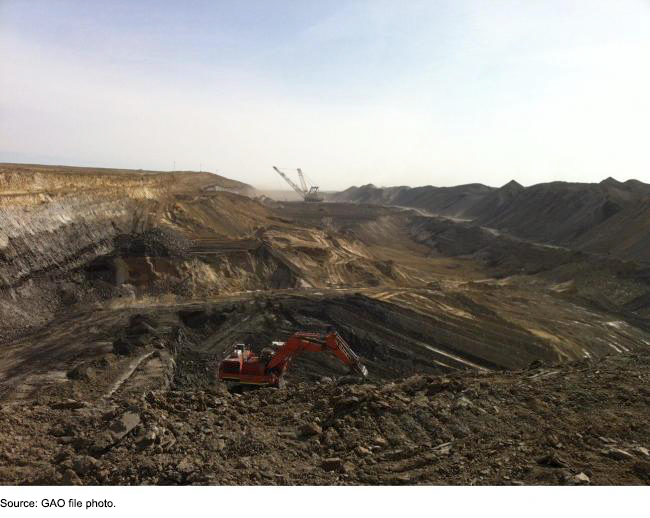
[0, 164, 256, 338]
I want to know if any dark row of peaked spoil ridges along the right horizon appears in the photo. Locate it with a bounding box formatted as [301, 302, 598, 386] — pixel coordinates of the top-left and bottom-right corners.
[331, 178, 650, 262]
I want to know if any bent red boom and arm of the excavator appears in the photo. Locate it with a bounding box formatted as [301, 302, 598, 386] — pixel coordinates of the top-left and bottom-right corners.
[267, 332, 368, 377]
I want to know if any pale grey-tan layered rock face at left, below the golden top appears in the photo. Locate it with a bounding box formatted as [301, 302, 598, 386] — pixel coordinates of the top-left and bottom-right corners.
[0, 182, 155, 344]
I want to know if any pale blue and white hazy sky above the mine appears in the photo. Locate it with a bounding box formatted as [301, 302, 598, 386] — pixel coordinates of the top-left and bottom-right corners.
[0, 0, 650, 189]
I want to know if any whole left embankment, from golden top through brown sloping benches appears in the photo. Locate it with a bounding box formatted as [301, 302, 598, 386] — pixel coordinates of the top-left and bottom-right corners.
[0, 164, 399, 340]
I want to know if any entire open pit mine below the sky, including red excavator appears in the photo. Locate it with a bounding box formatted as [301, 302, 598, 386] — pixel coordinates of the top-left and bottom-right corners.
[0, 164, 650, 485]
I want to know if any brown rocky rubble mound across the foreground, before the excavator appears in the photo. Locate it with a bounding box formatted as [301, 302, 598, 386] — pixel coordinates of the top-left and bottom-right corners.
[0, 354, 650, 485]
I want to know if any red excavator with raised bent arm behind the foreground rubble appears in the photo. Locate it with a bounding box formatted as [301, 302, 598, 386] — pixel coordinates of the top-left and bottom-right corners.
[219, 332, 368, 387]
